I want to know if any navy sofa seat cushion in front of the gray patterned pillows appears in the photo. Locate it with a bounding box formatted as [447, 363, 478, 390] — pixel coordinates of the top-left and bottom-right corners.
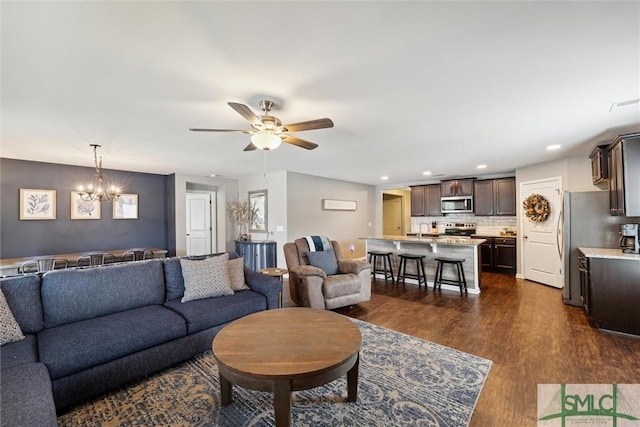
[165, 291, 267, 334]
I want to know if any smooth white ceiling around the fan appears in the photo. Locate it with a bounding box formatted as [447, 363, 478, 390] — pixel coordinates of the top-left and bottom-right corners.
[0, 1, 640, 185]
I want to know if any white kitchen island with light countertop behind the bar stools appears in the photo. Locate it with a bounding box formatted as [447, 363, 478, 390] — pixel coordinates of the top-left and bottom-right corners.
[361, 236, 486, 294]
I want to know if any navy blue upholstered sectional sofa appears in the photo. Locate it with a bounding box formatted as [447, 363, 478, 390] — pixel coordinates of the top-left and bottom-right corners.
[0, 253, 282, 427]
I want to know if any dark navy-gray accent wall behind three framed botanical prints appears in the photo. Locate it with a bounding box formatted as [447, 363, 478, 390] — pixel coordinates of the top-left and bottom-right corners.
[0, 159, 173, 258]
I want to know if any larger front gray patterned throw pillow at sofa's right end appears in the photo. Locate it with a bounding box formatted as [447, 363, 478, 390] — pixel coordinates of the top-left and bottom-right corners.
[180, 254, 233, 302]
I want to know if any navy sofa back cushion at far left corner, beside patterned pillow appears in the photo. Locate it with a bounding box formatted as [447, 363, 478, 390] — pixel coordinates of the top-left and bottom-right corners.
[0, 274, 44, 334]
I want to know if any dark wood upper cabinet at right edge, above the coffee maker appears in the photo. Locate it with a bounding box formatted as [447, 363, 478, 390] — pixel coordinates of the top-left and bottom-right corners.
[608, 133, 640, 216]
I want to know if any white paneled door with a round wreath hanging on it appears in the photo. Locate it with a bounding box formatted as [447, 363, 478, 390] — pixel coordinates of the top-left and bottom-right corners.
[520, 177, 564, 288]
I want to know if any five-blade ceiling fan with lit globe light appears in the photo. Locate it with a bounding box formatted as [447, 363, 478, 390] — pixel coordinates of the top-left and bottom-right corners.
[189, 100, 333, 151]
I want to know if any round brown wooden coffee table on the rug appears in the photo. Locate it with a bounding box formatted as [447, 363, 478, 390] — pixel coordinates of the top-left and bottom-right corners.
[212, 307, 362, 426]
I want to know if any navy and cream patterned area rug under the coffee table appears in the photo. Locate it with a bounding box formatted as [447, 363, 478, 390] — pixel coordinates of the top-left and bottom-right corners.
[58, 320, 492, 427]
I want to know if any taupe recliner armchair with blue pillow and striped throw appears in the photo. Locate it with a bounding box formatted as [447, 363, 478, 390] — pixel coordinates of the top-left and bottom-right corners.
[284, 238, 371, 309]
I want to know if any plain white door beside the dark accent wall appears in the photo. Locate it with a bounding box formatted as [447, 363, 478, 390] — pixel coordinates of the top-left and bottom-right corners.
[187, 193, 213, 255]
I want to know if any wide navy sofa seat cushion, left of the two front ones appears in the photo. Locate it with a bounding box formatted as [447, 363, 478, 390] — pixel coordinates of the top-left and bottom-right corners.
[38, 306, 187, 380]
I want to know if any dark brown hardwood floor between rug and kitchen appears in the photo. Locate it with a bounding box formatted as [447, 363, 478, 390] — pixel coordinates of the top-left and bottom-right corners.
[285, 273, 640, 427]
